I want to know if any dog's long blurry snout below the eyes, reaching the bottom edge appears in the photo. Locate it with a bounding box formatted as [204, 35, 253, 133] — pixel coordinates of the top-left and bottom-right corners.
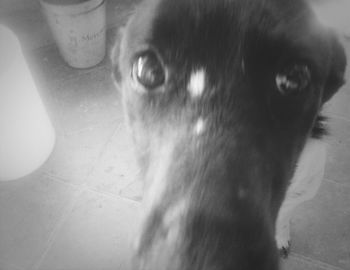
[135, 132, 278, 270]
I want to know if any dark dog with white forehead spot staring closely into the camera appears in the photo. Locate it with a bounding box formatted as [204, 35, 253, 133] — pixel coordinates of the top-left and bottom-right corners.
[114, 0, 346, 270]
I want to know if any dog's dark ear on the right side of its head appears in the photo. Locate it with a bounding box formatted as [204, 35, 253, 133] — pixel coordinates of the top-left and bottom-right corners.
[322, 31, 346, 103]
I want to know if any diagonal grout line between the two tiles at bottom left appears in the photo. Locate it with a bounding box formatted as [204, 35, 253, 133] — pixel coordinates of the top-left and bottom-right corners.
[32, 185, 86, 270]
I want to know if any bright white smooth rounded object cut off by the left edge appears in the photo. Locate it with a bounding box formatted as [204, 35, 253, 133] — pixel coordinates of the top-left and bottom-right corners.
[0, 25, 55, 181]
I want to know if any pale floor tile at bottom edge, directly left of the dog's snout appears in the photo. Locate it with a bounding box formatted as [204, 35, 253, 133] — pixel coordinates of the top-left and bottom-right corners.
[39, 191, 138, 270]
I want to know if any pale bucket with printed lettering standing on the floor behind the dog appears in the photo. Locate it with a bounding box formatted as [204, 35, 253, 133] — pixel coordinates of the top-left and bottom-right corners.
[40, 0, 106, 68]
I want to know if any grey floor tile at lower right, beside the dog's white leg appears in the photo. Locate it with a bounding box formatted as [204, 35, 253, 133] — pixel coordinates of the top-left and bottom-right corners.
[291, 181, 350, 269]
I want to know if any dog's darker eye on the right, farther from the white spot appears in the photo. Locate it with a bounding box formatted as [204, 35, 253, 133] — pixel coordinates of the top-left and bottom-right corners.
[275, 64, 311, 95]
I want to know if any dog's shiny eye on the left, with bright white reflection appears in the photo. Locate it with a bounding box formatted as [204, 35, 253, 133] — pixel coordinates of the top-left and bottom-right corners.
[132, 52, 165, 89]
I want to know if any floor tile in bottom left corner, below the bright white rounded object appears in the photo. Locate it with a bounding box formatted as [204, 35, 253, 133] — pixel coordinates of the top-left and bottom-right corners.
[0, 173, 76, 270]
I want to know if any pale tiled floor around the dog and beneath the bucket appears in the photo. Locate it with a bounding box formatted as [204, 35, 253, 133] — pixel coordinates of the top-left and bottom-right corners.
[0, 1, 350, 270]
